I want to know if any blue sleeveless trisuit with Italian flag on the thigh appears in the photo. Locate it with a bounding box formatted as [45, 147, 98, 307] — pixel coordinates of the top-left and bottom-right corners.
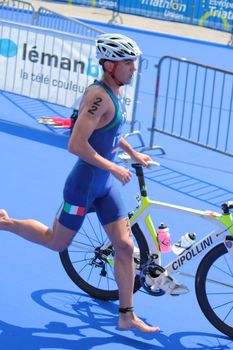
[57, 81, 127, 231]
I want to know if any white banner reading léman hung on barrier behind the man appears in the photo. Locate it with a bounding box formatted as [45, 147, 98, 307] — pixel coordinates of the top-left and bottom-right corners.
[0, 21, 137, 121]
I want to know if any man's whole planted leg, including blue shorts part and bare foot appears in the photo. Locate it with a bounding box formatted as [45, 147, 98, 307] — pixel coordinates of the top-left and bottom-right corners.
[94, 182, 159, 332]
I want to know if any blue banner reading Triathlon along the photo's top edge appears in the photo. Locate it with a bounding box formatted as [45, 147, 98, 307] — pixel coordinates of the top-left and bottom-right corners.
[59, 0, 233, 32]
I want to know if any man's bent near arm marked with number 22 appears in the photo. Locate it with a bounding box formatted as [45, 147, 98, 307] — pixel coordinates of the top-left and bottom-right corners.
[68, 88, 132, 184]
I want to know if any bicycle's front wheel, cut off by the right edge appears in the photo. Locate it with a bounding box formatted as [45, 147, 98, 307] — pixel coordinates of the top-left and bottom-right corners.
[195, 243, 233, 338]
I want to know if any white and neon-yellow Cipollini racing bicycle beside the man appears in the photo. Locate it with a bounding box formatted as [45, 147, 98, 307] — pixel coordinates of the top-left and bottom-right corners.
[59, 155, 233, 338]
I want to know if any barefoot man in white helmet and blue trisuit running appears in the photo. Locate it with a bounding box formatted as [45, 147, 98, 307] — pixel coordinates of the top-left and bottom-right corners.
[0, 34, 184, 333]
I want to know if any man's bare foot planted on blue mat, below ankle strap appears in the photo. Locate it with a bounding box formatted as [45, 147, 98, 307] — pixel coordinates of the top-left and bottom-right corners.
[119, 313, 160, 333]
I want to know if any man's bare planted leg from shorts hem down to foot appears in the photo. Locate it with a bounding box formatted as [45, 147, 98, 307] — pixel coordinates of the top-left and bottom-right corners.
[104, 218, 159, 333]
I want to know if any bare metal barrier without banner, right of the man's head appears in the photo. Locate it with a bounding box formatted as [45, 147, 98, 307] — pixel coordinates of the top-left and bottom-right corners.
[149, 56, 233, 156]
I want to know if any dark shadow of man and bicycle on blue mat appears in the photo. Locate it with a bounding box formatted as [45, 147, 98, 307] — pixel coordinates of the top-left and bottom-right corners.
[0, 289, 219, 350]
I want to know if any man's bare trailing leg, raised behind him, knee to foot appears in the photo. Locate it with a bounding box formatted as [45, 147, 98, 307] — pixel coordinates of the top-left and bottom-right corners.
[0, 209, 76, 251]
